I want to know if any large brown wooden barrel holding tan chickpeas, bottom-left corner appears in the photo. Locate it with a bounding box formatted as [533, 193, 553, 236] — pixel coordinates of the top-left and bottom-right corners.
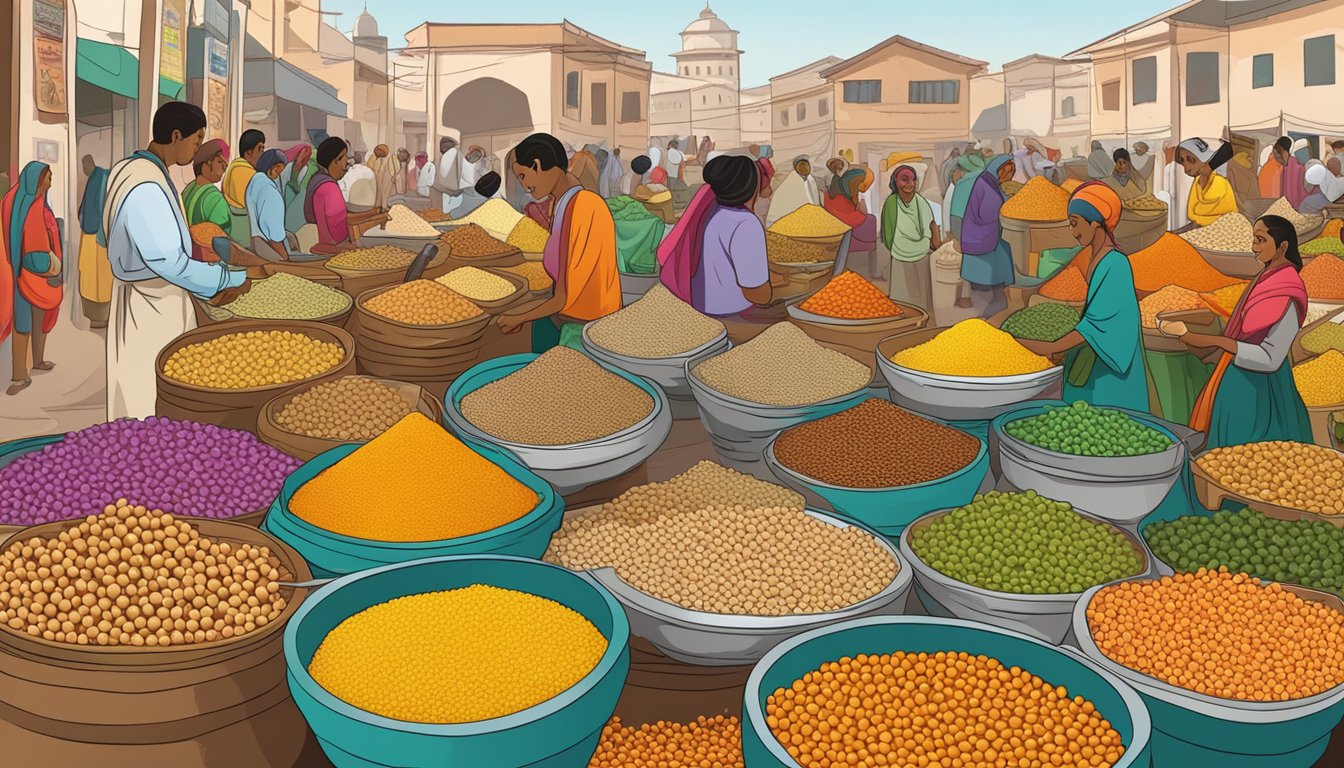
[0, 519, 312, 768]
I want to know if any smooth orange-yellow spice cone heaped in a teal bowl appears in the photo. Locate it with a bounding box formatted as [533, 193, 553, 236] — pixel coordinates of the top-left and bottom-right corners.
[289, 413, 538, 542]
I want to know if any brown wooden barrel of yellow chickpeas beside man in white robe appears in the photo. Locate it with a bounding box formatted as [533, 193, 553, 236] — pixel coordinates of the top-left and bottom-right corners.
[155, 320, 355, 432]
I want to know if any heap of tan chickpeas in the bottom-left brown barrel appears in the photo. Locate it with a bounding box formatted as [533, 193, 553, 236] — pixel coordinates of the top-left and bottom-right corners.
[0, 499, 290, 648]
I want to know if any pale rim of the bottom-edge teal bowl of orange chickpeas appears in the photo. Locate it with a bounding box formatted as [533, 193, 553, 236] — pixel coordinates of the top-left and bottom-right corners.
[742, 616, 1153, 768]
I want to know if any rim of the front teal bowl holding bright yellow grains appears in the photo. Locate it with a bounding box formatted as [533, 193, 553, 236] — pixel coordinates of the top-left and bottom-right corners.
[284, 554, 630, 737]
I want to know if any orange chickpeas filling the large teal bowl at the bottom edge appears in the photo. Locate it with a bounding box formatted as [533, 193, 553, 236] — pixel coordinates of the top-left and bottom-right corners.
[765, 651, 1125, 768]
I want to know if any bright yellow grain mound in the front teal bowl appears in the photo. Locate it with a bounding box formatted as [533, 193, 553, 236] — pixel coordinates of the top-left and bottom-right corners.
[308, 584, 607, 724]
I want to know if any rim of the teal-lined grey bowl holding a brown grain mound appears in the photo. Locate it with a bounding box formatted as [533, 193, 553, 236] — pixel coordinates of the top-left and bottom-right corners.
[444, 352, 668, 454]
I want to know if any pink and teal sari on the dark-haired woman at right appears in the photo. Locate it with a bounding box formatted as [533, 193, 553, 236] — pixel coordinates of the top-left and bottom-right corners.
[1189, 265, 1312, 449]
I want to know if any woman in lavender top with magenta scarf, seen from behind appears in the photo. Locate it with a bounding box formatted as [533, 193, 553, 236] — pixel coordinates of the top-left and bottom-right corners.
[659, 156, 774, 317]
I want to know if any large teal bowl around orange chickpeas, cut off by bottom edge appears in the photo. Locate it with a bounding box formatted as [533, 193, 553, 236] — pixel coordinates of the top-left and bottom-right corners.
[741, 618, 1150, 768]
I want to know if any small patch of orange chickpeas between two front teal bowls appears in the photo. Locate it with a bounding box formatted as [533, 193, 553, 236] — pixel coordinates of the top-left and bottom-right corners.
[589, 714, 745, 768]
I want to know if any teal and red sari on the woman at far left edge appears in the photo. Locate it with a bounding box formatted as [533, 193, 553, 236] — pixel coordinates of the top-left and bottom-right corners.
[0, 161, 62, 340]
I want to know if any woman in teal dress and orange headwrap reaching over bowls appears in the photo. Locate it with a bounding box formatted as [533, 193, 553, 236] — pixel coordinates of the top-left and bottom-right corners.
[1021, 182, 1148, 412]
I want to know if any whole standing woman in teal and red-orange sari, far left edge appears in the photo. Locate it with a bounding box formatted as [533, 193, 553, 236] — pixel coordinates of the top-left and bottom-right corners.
[0, 161, 62, 395]
